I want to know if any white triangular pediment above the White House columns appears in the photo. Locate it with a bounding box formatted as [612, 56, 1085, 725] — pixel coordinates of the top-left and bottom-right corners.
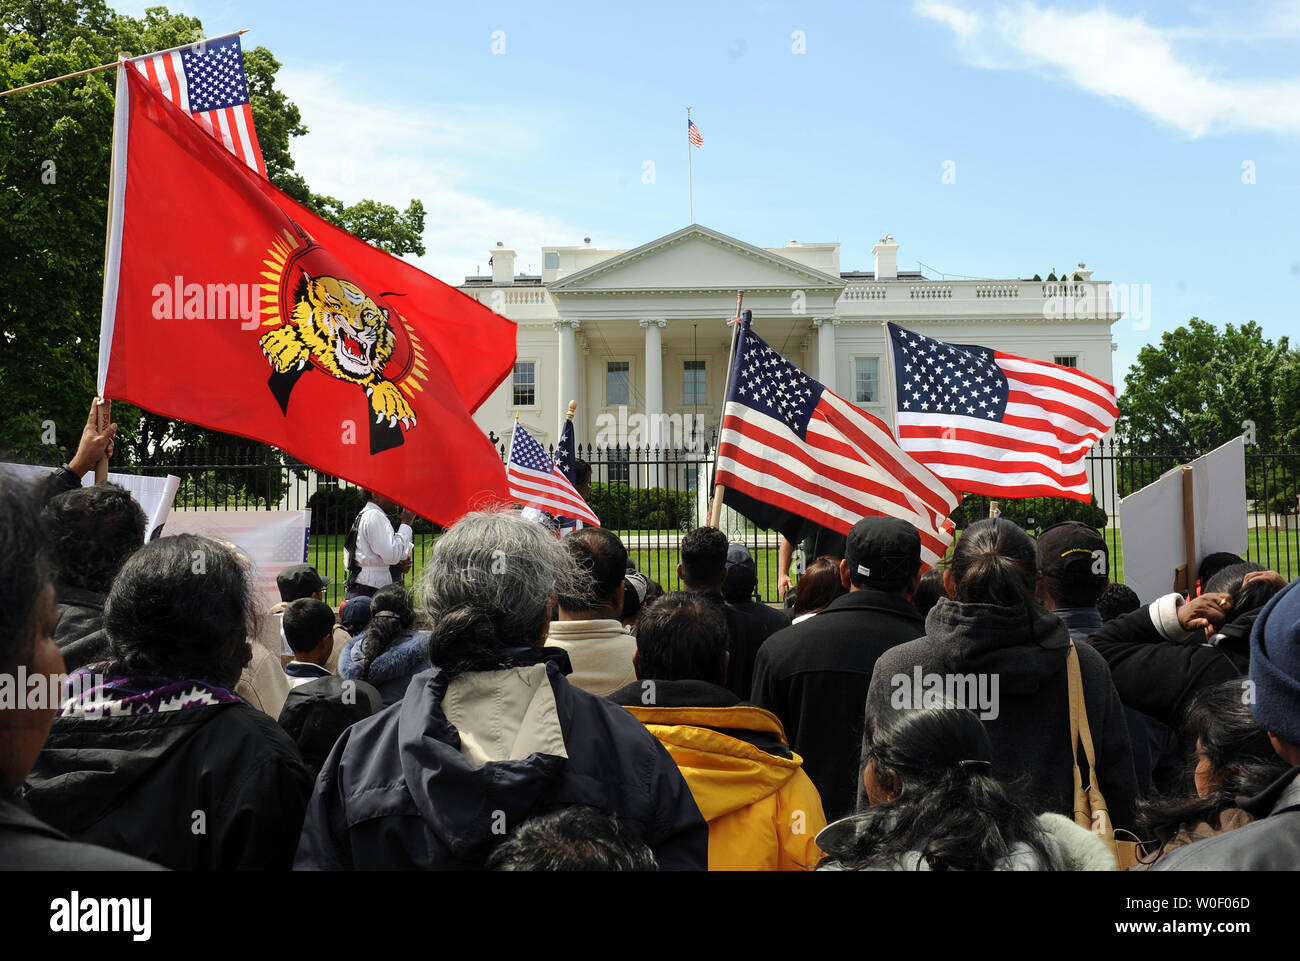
[547, 224, 844, 294]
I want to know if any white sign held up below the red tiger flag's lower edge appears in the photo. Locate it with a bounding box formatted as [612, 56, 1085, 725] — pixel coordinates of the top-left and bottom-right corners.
[163, 511, 312, 611]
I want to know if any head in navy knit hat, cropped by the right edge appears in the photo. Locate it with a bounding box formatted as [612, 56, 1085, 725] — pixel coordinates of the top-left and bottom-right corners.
[1251, 577, 1300, 765]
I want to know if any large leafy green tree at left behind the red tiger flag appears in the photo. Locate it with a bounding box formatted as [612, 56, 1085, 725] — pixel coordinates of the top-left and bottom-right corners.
[0, 0, 424, 473]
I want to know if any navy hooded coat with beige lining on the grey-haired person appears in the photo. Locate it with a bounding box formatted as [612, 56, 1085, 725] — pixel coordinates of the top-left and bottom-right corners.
[294, 648, 709, 871]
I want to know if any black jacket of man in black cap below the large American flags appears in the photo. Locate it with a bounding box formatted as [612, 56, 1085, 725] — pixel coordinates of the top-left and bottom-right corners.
[750, 590, 926, 821]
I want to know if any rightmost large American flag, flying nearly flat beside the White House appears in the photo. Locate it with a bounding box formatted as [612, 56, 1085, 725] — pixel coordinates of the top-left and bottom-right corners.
[887, 324, 1119, 501]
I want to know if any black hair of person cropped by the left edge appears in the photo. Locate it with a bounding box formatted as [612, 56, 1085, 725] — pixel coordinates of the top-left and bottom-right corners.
[0, 471, 51, 674]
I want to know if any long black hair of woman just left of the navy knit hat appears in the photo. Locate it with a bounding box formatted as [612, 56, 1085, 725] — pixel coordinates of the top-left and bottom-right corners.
[1138, 678, 1287, 844]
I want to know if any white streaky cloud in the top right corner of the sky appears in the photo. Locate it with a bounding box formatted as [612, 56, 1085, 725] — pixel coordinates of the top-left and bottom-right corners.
[915, 1, 1300, 137]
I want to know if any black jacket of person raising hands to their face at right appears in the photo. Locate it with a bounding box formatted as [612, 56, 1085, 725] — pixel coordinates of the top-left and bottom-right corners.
[1089, 607, 1237, 727]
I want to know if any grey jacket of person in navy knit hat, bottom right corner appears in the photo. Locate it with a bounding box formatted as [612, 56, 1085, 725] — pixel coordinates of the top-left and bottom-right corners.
[1151, 767, 1300, 871]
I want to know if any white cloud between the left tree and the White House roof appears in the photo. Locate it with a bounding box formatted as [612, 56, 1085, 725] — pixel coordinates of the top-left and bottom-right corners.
[276, 68, 595, 283]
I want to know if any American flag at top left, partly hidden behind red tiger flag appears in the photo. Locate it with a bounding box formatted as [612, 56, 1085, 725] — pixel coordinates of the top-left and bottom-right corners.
[127, 34, 267, 177]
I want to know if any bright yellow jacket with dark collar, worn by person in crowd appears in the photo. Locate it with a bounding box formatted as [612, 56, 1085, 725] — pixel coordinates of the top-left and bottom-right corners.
[624, 705, 826, 871]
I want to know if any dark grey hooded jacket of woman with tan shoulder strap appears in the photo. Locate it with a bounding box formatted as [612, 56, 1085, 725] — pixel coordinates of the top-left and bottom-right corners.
[873, 597, 1138, 830]
